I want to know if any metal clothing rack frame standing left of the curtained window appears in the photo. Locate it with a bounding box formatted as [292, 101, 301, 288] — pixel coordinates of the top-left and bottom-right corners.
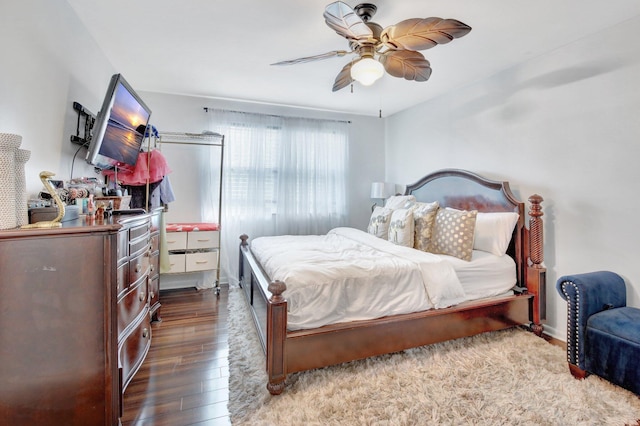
[154, 132, 224, 296]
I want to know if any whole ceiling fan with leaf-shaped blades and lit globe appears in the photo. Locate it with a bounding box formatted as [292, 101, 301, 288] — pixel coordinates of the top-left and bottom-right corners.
[271, 1, 471, 92]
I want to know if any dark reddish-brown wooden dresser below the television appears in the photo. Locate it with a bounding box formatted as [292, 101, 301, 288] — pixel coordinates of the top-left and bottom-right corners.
[0, 210, 161, 425]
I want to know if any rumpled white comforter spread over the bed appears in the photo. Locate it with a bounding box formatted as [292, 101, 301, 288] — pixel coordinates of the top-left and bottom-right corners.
[251, 228, 465, 330]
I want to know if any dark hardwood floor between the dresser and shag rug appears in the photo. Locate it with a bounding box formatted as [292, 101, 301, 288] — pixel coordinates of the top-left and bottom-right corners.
[122, 286, 231, 426]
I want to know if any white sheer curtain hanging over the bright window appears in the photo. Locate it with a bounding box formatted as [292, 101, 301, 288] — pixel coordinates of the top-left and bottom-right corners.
[208, 109, 349, 283]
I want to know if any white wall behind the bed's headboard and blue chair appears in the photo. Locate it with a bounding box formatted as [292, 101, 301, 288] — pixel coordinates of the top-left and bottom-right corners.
[386, 18, 640, 340]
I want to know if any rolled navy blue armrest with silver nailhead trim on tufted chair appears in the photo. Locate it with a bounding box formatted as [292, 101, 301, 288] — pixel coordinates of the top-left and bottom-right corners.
[556, 271, 627, 370]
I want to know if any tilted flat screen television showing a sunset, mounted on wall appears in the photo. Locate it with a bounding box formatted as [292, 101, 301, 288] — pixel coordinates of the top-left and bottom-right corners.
[86, 74, 151, 170]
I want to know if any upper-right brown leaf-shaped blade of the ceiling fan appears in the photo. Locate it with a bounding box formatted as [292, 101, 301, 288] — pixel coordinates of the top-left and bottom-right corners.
[380, 18, 471, 50]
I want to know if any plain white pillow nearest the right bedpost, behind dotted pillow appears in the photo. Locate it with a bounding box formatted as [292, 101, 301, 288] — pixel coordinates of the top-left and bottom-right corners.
[473, 212, 519, 256]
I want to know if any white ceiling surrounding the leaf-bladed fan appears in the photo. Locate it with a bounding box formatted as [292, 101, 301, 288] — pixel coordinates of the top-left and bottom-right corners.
[67, 0, 640, 116]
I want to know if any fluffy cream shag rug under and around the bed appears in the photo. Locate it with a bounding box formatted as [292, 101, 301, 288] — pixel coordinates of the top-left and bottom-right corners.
[228, 286, 640, 426]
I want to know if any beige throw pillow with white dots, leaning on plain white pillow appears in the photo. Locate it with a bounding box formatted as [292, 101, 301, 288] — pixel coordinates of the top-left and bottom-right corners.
[429, 209, 478, 261]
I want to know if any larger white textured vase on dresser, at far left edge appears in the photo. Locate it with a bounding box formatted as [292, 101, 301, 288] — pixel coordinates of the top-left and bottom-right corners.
[0, 133, 22, 229]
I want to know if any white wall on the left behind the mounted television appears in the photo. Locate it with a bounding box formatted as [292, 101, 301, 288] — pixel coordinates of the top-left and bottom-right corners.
[0, 0, 119, 194]
